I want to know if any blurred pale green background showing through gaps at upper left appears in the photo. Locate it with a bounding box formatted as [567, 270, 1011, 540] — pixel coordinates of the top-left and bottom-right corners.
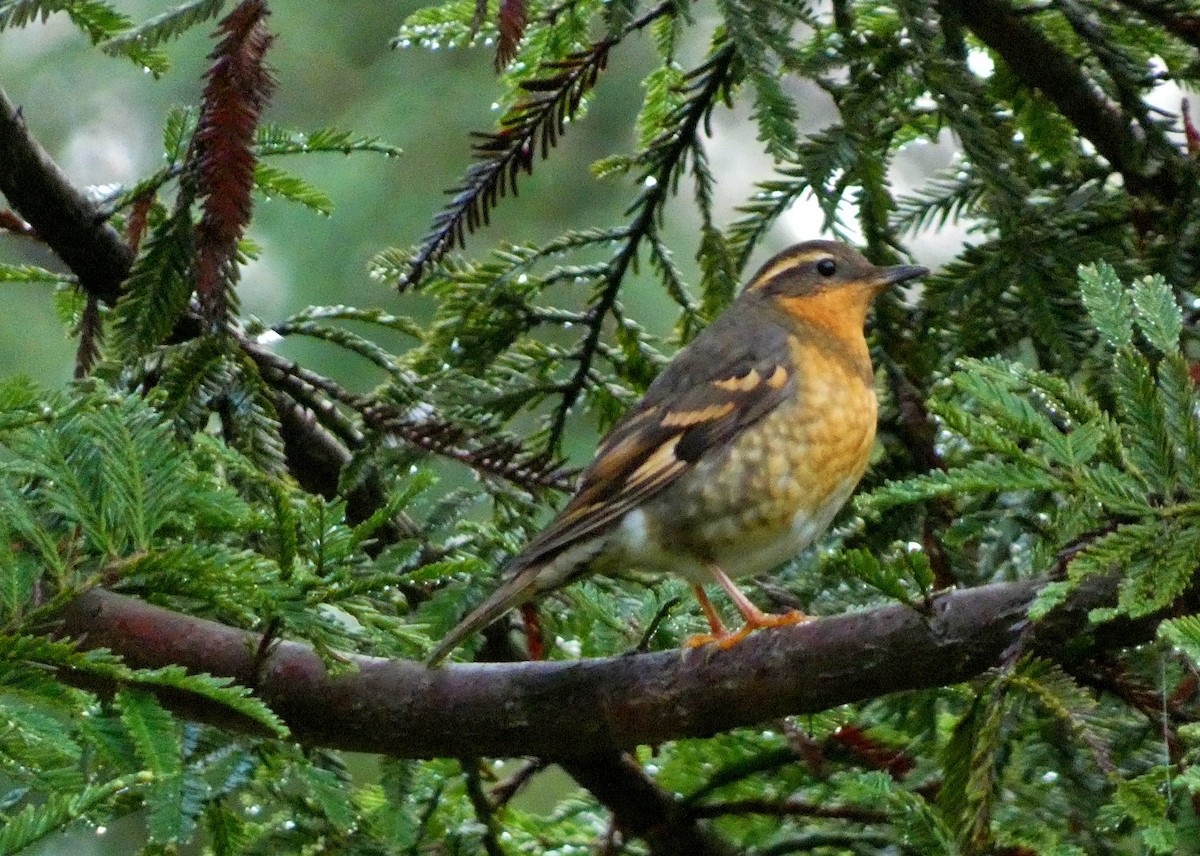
[0, 0, 686, 385]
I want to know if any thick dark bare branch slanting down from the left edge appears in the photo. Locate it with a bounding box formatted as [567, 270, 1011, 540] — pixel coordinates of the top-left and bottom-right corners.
[0, 89, 133, 304]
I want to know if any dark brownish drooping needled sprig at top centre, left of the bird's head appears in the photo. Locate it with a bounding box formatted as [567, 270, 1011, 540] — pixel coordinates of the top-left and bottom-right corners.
[398, 2, 674, 291]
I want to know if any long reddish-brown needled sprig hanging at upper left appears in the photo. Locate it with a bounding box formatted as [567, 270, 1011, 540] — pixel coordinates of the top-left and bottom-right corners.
[190, 0, 275, 325]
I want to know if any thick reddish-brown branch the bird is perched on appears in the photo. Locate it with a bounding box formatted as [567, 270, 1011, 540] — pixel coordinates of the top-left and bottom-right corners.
[51, 580, 1154, 760]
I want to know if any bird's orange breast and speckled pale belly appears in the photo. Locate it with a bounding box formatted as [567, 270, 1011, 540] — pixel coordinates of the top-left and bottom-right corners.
[614, 336, 877, 582]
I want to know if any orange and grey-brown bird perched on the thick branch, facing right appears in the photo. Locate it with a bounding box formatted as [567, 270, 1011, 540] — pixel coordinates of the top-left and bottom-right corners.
[426, 240, 929, 666]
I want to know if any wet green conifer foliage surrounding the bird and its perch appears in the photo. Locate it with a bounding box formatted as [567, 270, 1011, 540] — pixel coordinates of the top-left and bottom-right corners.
[7, 0, 1200, 856]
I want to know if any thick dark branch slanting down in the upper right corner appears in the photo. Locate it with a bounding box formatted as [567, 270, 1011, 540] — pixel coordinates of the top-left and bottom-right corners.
[944, 0, 1177, 202]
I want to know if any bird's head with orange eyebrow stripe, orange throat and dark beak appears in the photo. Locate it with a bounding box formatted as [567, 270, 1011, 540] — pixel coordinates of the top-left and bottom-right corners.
[739, 241, 929, 339]
